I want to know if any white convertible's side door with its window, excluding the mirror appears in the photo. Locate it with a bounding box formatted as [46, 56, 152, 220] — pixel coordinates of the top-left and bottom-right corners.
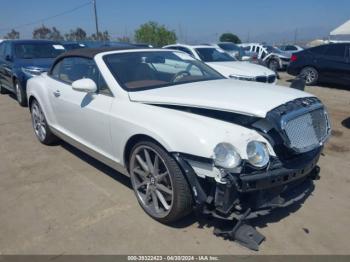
[48, 57, 113, 158]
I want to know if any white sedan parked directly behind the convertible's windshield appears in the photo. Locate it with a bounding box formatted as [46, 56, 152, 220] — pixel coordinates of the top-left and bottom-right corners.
[164, 44, 277, 84]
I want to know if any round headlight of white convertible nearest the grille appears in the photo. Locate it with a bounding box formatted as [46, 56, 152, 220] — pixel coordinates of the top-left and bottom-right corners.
[247, 141, 270, 167]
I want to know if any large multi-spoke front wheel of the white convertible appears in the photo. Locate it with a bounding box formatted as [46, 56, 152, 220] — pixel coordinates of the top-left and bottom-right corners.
[129, 141, 193, 224]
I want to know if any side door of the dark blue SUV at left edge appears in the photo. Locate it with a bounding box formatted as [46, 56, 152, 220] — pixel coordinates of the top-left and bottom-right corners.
[0, 42, 13, 90]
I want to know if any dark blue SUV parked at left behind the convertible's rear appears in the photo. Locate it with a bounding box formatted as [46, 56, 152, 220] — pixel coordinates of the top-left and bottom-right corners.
[0, 40, 65, 106]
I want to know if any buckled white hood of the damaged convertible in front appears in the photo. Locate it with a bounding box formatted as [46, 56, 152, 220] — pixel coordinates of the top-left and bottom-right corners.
[129, 79, 312, 118]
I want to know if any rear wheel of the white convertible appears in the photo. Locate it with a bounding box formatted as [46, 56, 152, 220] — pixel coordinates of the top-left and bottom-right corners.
[30, 100, 59, 145]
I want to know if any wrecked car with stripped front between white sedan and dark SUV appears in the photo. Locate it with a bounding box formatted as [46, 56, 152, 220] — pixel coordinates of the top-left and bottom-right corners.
[240, 43, 291, 71]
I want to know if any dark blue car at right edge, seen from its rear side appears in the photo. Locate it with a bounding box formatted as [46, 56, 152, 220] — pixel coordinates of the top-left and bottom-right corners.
[287, 43, 350, 85]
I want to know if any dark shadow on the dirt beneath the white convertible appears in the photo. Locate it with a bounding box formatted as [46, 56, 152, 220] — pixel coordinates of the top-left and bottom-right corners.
[59, 141, 314, 233]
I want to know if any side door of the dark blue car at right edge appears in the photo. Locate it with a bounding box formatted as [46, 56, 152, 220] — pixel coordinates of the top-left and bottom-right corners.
[319, 44, 349, 82]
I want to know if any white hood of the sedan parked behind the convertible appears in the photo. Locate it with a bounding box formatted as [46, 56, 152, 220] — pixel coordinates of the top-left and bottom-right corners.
[206, 61, 275, 77]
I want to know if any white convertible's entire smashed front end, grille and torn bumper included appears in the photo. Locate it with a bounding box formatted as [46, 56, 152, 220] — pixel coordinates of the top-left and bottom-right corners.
[174, 98, 330, 250]
